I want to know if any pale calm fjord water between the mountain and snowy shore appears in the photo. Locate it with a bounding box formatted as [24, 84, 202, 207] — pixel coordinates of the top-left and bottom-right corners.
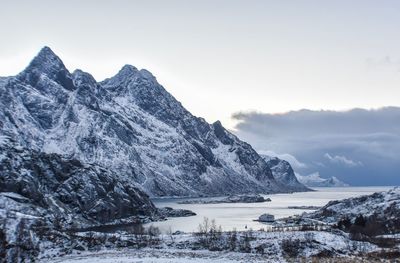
[151, 187, 393, 232]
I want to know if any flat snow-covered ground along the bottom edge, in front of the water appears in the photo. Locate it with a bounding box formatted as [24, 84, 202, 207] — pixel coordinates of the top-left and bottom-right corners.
[40, 231, 390, 263]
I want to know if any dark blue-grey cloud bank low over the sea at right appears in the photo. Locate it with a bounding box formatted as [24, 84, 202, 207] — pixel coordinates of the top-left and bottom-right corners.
[233, 107, 400, 185]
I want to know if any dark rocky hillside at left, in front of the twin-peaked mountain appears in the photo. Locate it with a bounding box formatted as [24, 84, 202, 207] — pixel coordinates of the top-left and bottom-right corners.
[0, 136, 157, 225]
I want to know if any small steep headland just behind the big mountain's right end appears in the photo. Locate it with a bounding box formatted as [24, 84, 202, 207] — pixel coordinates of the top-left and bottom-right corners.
[262, 155, 309, 191]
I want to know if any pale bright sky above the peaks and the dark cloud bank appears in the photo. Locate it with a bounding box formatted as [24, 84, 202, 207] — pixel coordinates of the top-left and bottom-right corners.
[0, 0, 400, 128]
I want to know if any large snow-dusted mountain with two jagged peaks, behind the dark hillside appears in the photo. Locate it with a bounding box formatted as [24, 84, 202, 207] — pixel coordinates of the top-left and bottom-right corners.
[0, 47, 308, 196]
